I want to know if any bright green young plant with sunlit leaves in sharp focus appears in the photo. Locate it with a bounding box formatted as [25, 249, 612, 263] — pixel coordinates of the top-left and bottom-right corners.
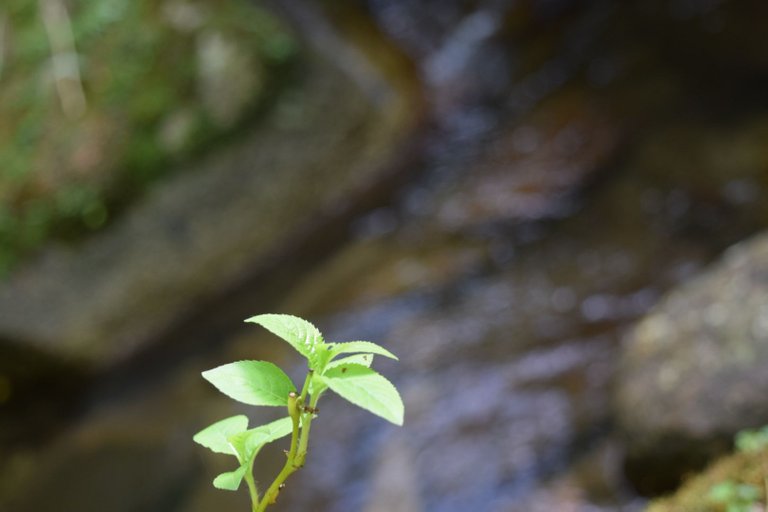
[193, 315, 404, 512]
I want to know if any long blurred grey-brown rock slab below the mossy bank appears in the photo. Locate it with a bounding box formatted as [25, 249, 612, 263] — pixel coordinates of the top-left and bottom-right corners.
[0, 15, 417, 364]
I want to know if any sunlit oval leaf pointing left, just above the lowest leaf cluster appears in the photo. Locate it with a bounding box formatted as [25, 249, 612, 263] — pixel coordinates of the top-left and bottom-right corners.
[203, 361, 296, 406]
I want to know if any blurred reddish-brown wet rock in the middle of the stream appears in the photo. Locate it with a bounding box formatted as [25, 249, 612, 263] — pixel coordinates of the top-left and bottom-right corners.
[437, 89, 621, 229]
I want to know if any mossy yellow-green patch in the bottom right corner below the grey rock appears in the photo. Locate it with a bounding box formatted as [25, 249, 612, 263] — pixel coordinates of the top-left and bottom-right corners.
[646, 446, 768, 512]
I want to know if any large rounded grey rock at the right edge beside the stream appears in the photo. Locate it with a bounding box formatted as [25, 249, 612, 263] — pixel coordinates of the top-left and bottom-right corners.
[615, 234, 768, 490]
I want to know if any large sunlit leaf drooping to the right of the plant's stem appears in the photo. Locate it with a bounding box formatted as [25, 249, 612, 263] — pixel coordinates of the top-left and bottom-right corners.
[320, 363, 404, 425]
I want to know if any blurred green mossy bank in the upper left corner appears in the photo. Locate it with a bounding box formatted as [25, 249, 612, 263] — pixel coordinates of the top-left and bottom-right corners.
[0, 0, 297, 276]
